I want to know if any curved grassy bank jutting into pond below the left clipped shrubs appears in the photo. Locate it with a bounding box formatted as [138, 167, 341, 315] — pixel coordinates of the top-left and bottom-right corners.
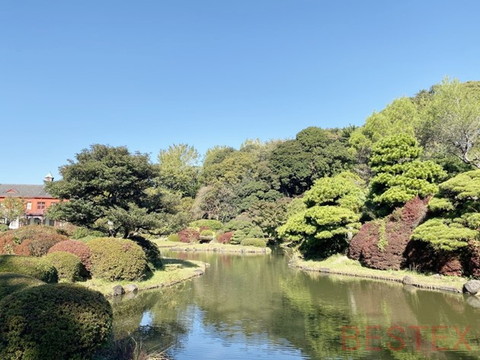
[80, 258, 208, 296]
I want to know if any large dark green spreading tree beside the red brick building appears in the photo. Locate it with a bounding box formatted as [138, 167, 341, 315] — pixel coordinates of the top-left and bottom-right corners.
[46, 144, 157, 235]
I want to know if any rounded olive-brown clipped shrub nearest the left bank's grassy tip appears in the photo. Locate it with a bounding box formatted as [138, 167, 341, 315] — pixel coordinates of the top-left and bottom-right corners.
[87, 238, 148, 281]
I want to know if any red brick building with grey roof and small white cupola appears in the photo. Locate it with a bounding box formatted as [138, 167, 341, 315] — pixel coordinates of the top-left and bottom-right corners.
[0, 174, 60, 228]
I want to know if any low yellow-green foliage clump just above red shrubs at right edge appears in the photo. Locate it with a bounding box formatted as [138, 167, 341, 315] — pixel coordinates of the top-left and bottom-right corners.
[412, 218, 479, 251]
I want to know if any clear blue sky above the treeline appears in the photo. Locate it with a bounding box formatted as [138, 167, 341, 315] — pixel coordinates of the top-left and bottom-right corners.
[0, 0, 480, 183]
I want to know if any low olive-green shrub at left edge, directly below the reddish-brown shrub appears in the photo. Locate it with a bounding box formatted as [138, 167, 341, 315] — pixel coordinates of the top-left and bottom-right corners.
[0, 255, 58, 283]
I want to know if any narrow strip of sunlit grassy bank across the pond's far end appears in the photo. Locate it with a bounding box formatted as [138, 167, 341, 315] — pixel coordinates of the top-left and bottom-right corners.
[151, 239, 272, 254]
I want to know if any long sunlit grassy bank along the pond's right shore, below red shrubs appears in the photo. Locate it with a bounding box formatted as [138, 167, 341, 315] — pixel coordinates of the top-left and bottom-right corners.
[290, 254, 469, 293]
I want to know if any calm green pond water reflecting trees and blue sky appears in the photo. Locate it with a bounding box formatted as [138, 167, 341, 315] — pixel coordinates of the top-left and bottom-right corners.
[114, 253, 480, 360]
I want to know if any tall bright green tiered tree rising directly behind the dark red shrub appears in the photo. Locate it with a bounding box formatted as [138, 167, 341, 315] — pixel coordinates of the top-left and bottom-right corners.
[370, 134, 446, 214]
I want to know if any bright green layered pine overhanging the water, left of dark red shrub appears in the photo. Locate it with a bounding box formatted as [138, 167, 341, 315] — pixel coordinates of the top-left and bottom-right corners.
[277, 172, 365, 257]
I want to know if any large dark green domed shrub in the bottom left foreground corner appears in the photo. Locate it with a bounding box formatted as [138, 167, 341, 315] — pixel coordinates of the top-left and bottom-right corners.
[0, 284, 112, 360]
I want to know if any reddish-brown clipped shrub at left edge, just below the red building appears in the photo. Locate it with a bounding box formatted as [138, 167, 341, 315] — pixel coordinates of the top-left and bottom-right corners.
[0, 225, 68, 256]
